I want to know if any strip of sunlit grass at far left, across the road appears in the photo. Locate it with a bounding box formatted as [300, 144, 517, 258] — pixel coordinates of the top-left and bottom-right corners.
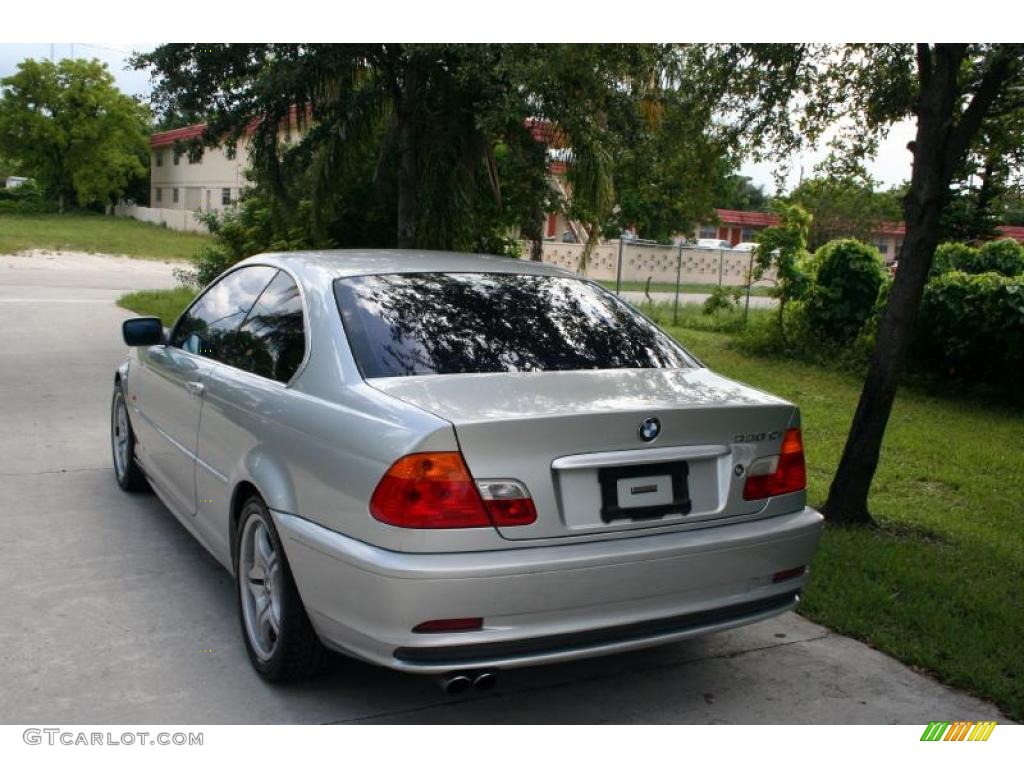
[0, 213, 210, 260]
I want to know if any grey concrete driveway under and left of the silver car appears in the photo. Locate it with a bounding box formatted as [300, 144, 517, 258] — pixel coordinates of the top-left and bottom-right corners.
[0, 249, 999, 724]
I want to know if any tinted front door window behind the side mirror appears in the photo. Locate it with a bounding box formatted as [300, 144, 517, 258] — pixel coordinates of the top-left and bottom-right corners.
[170, 266, 276, 365]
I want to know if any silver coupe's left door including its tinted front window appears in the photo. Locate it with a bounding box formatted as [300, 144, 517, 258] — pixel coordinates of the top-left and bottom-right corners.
[140, 266, 276, 515]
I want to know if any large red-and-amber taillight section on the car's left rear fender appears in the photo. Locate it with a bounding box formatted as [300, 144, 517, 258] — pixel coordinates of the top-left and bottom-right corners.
[370, 451, 492, 528]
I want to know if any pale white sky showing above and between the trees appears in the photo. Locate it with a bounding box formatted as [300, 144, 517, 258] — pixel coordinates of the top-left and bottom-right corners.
[0, 43, 913, 194]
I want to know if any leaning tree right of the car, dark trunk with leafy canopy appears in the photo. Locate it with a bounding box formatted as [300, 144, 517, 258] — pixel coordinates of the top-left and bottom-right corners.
[682, 43, 1024, 523]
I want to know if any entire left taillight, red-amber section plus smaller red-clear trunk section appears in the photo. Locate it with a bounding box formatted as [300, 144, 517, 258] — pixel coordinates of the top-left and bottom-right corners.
[370, 451, 537, 528]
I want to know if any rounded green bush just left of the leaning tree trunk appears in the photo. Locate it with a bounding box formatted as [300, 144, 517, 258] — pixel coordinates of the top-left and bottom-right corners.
[806, 239, 885, 342]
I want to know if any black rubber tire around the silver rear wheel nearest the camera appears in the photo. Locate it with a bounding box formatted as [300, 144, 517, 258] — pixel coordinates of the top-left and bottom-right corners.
[233, 496, 327, 683]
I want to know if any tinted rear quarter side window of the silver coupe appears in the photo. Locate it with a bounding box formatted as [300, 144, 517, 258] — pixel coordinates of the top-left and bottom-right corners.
[233, 271, 306, 383]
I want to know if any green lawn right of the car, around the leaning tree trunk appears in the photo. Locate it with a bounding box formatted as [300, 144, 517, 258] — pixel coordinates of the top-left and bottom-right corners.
[671, 329, 1024, 720]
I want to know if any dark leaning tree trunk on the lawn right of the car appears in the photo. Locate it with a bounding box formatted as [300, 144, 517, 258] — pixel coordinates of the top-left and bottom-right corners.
[822, 46, 962, 524]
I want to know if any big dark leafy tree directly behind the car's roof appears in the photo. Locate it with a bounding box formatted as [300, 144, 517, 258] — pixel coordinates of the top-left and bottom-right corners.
[136, 44, 671, 257]
